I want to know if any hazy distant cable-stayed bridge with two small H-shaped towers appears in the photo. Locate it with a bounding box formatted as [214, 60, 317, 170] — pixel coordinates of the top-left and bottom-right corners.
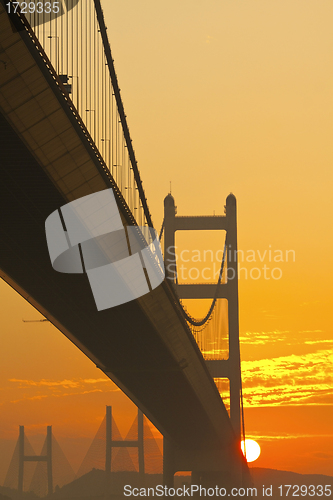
[4, 406, 163, 497]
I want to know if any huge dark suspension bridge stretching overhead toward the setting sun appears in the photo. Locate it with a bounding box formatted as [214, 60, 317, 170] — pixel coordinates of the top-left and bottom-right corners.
[0, 0, 248, 490]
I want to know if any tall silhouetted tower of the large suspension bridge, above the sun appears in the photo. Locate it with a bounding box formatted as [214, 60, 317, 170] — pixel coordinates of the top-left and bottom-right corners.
[164, 194, 241, 441]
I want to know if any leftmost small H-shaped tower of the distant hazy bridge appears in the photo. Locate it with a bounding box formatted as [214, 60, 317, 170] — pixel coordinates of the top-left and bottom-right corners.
[18, 425, 53, 495]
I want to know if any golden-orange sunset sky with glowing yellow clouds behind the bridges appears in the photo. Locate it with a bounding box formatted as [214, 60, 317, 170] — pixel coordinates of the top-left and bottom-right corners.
[0, 0, 333, 484]
